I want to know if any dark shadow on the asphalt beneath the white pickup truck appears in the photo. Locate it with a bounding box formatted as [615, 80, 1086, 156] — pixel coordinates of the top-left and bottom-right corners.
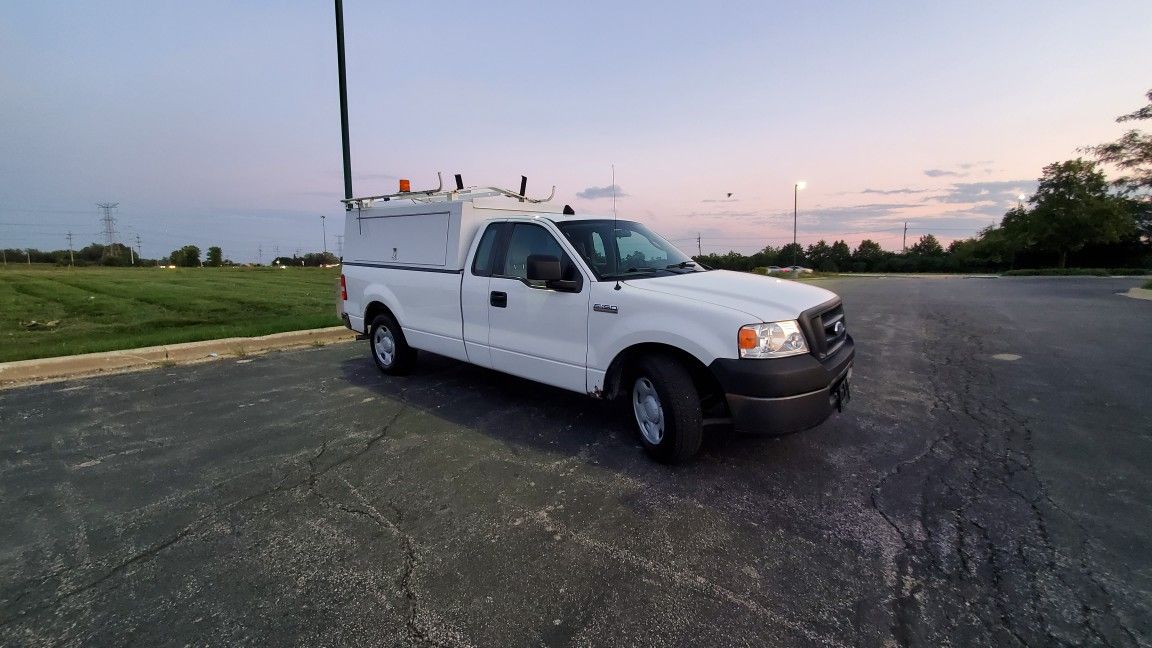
[341, 352, 838, 476]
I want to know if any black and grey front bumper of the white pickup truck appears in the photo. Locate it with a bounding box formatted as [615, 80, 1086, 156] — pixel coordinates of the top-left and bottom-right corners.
[710, 336, 856, 436]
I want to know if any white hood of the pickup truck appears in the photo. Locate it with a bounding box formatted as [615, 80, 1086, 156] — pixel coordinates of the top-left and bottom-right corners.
[624, 270, 836, 323]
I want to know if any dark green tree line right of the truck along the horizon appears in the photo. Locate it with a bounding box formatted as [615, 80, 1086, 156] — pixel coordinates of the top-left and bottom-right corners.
[694, 90, 1152, 272]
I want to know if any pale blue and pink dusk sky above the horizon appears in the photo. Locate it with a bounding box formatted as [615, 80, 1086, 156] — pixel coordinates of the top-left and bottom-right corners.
[0, 0, 1152, 262]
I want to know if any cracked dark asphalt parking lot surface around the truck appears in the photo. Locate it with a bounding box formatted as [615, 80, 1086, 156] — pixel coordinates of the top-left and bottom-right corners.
[0, 278, 1152, 646]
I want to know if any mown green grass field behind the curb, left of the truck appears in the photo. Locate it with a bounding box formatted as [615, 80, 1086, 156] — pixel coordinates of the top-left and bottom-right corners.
[0, 265, 340, 362]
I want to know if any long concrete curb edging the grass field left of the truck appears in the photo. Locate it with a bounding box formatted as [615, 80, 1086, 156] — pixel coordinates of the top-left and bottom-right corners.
[0, 326, 356, 389]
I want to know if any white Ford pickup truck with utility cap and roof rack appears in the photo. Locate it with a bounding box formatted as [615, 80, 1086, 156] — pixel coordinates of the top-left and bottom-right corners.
[341, 188, 855, 462]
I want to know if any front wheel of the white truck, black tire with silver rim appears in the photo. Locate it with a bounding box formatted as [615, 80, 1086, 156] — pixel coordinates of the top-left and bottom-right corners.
[624, 355, 704, 464]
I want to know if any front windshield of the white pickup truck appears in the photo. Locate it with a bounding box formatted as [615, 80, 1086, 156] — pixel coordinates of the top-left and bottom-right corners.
[556, 219, 704, 281]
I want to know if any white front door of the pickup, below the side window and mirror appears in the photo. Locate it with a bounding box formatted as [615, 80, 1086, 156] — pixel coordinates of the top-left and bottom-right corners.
[488, 223, 591, 392]
